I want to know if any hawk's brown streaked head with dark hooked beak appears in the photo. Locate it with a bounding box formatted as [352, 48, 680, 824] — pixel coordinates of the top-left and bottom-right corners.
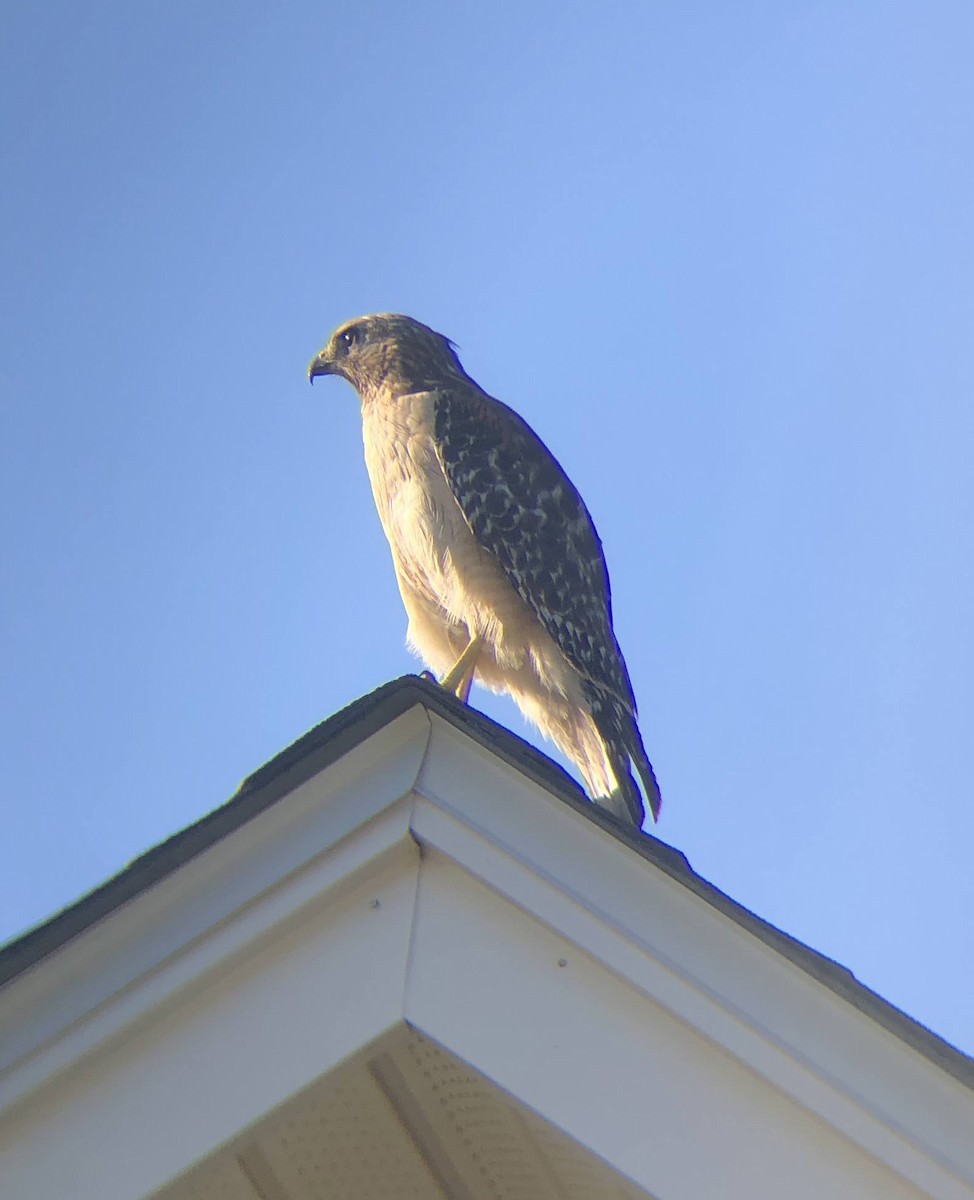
[308, 312, 467, 398]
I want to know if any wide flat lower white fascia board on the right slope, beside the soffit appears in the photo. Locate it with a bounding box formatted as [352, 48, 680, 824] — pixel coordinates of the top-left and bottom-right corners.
[405, 848, 935, 1200]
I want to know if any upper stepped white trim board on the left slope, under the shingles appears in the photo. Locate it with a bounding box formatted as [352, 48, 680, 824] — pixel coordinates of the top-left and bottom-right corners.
[0, 707, 429, 1112]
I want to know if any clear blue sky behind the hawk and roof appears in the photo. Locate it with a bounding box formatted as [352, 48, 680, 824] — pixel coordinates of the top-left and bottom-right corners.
[0, 0, 974, 1052]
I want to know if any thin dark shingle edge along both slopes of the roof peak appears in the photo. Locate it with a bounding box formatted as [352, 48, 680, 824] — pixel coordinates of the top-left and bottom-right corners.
[0, 676, 974, 1088]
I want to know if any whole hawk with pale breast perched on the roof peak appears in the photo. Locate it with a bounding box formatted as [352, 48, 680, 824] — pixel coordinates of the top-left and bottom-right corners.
[308, 313, 660, 828]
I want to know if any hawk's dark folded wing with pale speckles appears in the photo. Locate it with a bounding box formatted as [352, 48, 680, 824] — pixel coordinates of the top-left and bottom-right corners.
[434, 388, 636, 713]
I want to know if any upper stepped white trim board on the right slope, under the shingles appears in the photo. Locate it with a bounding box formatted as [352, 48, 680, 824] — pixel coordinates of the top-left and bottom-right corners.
[414, 716, 974, 1200]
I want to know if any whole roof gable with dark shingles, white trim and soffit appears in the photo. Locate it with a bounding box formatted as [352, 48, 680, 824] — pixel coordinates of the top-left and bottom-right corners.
[0, 679, 974, 1200]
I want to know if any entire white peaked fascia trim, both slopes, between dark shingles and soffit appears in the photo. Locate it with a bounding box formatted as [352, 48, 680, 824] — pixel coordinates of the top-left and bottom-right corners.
[0, 704, 974, 1200]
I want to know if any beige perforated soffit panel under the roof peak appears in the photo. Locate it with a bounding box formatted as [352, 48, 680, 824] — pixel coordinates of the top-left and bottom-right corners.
[156, 1027, 648, 1200]
